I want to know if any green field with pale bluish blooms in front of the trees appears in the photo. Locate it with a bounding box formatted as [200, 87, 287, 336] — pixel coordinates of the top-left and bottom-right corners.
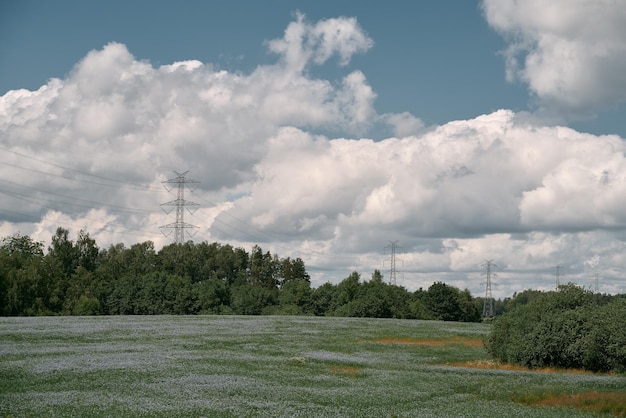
[0, 316, 626, 417]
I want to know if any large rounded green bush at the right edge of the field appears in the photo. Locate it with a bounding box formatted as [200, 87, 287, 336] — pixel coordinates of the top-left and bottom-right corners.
[487, 285, 626, 371]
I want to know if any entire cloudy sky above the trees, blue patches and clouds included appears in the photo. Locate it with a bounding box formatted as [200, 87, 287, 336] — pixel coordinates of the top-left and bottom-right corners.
[0, 0, 626, 298]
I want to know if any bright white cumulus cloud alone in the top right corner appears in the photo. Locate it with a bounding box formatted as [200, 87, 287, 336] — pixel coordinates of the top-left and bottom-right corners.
[483, 0, 626, 118]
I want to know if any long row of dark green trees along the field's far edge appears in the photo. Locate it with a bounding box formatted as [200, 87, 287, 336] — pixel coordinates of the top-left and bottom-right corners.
[0, 228, 482, 322]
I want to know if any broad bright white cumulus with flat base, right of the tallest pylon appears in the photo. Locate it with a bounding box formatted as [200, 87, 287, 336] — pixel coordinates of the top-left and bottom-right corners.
[227, 110, 626, 242]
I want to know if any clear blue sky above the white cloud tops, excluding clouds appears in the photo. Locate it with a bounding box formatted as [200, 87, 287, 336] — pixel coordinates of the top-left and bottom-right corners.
[0, 0, 604, 135]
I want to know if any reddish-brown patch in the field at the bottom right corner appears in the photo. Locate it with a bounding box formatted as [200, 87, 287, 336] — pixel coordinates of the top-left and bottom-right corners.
[515, 392, 626, 417]
